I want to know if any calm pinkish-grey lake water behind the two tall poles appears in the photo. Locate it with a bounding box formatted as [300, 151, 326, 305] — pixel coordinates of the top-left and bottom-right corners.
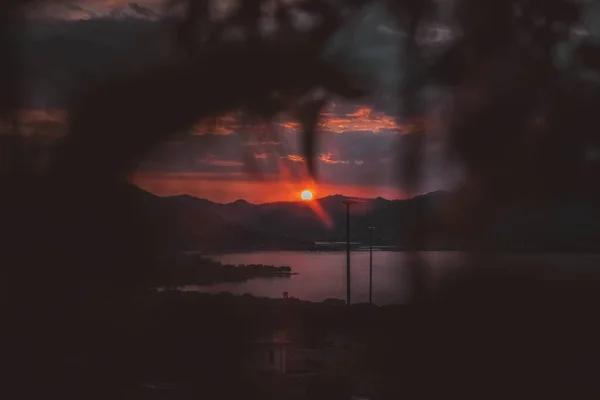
[181, 251, 462, 304]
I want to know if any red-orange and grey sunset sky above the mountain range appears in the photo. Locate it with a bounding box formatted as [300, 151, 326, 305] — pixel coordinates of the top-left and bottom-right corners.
[12, 0, 468, 203]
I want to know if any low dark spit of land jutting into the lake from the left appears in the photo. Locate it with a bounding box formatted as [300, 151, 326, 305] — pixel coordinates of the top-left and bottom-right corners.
[152, 254, 295, 287]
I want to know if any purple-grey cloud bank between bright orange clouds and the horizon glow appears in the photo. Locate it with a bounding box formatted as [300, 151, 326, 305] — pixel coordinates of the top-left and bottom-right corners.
[139, 125, 398, 191]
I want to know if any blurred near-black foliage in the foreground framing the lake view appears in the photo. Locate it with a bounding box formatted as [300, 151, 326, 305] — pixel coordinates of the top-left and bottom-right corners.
[0, 0, 600, 399]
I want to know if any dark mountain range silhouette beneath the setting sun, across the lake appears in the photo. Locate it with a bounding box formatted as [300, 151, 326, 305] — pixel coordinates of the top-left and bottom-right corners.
[125, 185, 600, 251]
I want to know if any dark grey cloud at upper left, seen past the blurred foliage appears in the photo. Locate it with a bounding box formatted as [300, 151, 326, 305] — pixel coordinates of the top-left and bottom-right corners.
[20, 18, 168, 108]
